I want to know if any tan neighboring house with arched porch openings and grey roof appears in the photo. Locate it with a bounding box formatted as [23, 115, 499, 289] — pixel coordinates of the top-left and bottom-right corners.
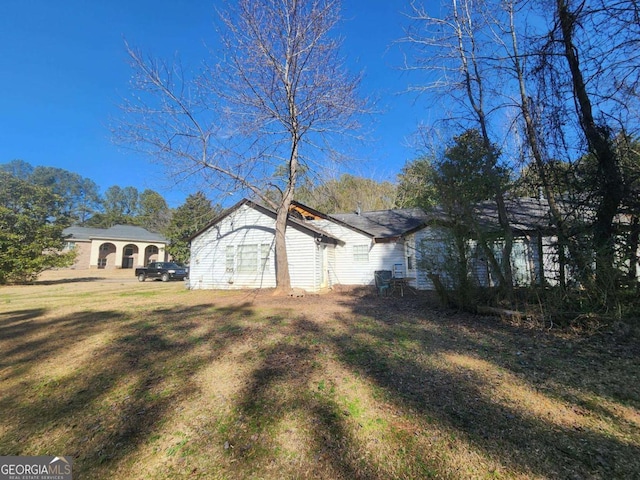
[63, 225, 169, 270]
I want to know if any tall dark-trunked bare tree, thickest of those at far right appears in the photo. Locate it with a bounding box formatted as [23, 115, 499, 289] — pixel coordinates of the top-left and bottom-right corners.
[535, 0, 640, 300]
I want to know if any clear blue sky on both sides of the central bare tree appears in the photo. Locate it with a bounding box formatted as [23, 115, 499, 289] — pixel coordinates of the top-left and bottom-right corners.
[0, 0, 428, 206]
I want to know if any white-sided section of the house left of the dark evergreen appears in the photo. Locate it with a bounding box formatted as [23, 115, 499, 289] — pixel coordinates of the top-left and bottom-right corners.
[189, 200, 426, 292]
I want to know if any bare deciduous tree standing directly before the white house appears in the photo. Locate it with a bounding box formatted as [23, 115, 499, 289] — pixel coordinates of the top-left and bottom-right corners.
[120, 0, 364, 291]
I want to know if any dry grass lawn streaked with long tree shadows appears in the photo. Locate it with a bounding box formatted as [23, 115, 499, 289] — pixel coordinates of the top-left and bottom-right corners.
[0, 271, 640, 479]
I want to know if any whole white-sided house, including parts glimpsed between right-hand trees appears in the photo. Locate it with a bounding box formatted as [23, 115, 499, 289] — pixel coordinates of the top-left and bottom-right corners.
[185, 195, 558, 292]
